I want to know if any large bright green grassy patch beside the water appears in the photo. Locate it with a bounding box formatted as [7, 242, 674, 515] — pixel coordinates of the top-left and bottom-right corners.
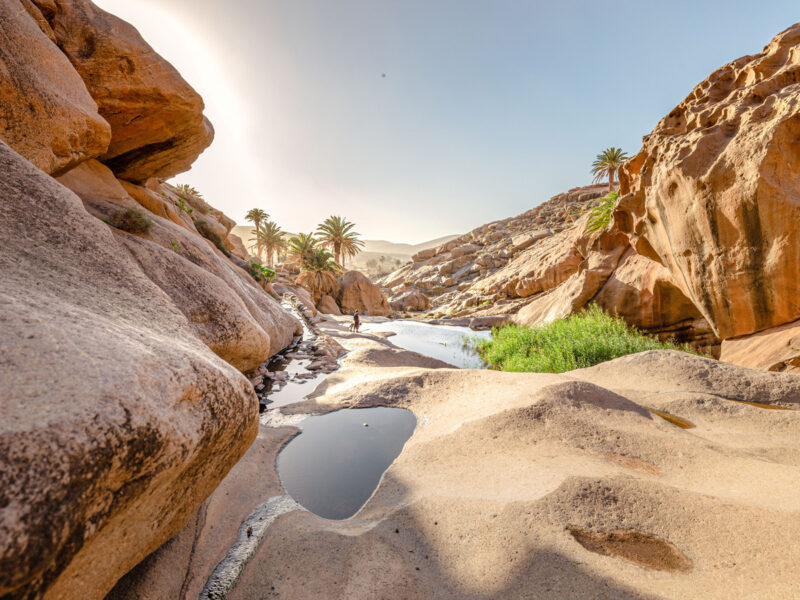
[470, 305, 695, 373]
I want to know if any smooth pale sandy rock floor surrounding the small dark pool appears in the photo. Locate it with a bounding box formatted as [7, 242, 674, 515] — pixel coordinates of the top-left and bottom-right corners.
[109, 321, 800, 600]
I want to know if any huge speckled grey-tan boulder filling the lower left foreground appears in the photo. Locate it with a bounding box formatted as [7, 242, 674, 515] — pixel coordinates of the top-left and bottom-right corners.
[0, 143, 258, 598]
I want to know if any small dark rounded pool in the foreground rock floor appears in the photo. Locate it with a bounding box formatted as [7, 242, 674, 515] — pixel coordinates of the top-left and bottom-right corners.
[278, 406, 417, 519]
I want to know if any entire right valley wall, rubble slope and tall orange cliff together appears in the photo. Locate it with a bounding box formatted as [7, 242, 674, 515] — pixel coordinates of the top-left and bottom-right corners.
[382, 25, 800, 370]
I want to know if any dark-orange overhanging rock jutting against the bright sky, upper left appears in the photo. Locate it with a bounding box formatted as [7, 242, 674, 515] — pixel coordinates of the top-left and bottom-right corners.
[34, 0, 214, 182]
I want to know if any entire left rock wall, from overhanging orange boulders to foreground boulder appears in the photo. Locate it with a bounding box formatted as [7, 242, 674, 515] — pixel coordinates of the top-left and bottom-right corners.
[0, 0, 300, 598]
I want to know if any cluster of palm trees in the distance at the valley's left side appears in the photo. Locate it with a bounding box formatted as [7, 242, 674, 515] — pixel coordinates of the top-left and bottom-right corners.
[245, 208, 364, 272]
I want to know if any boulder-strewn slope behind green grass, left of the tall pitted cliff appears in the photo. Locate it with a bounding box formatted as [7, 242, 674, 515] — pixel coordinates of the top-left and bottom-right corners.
[381, 185, 718, 352]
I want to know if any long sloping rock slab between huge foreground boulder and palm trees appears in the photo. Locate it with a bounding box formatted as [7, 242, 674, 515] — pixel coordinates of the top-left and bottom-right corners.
[58, 161, 300, 371]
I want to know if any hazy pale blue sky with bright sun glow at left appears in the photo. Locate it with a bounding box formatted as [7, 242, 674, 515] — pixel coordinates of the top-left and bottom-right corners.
[90, 0, 800, 243]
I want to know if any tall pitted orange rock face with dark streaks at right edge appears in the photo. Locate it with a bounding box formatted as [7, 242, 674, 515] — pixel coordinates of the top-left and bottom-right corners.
[615, 24, 800, 339]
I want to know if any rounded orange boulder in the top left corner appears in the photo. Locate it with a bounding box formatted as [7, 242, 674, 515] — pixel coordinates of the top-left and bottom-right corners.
[0, 0, 111, 174]
